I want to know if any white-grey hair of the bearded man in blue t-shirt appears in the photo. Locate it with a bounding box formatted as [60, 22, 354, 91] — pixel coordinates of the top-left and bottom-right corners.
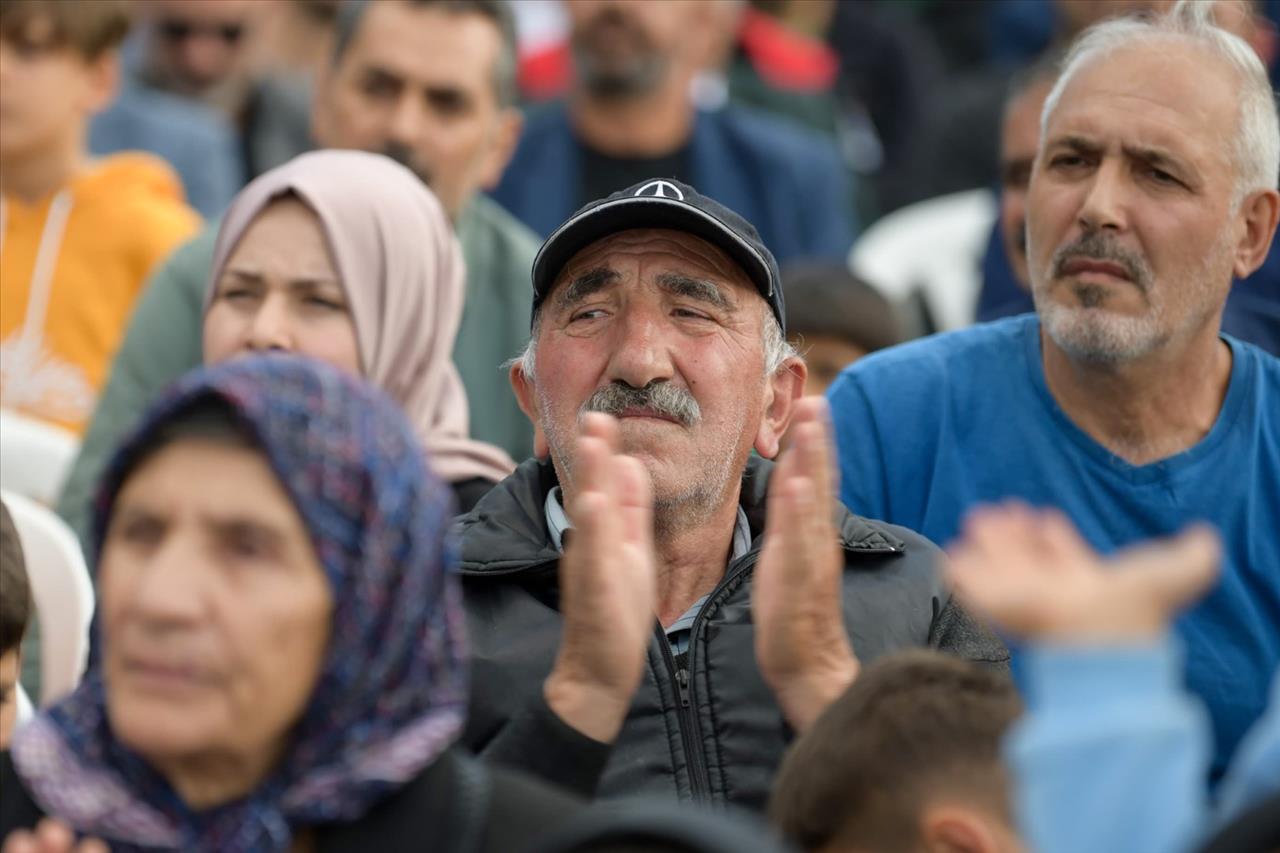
[1041, 0, 1280, 207]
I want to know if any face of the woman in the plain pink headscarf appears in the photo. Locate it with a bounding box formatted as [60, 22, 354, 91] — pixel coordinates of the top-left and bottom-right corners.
[205, 197, 362, 375]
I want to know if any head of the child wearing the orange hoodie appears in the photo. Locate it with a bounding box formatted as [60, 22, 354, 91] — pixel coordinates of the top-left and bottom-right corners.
[0, 0, 129, 163]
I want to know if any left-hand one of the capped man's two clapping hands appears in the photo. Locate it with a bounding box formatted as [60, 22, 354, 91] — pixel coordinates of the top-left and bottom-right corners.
[543, 412, 657, 743]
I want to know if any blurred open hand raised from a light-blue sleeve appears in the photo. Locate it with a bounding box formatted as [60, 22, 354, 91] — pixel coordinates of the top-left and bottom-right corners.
[947, 503, 1221, 644]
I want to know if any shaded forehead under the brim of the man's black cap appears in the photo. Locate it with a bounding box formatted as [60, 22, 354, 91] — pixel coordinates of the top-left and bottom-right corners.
[547, 228, 763, 301]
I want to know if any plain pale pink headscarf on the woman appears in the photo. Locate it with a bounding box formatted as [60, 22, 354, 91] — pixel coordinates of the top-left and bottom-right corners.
[205, 151, 515, 483]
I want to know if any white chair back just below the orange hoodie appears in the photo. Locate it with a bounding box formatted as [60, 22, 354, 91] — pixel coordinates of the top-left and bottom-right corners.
[0, 409, 79, 506]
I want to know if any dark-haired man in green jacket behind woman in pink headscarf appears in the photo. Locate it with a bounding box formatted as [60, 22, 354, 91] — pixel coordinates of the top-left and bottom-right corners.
[58, 0, 539, 542]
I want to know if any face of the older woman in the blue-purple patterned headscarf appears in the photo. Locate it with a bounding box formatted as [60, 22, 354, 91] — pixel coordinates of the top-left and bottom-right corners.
[99, 438, 333, 772]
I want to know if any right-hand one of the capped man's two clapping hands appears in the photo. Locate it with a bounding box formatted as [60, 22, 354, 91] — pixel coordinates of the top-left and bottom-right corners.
[751, 397, 858, 731]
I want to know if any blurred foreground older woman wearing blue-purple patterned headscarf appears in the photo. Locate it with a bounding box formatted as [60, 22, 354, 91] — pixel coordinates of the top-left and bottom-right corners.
[0, 357, 575, 850]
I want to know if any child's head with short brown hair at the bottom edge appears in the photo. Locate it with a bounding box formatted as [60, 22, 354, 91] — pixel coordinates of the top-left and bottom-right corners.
[769, 651, 1021, 853]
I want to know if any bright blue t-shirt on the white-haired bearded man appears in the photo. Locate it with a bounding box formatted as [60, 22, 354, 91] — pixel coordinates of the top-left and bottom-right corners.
[828, 314, 1280, 779]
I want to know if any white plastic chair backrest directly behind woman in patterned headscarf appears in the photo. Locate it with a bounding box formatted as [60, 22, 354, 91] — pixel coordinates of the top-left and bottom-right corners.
[0, 489, 93, 706]
